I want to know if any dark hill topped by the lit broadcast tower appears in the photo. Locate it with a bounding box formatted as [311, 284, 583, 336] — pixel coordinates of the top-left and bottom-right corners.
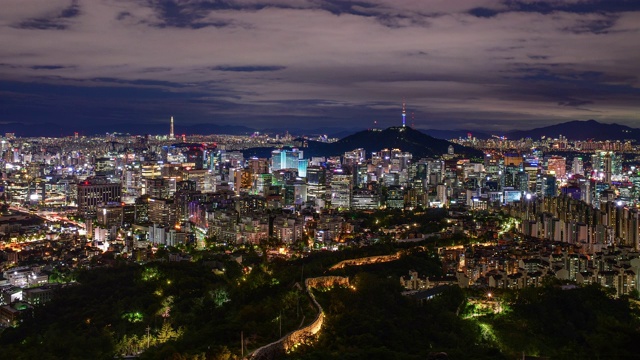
[304, 127, 483, 159]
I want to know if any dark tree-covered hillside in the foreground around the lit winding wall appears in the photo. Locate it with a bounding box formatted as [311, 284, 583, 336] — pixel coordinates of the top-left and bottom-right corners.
[0, 242, 640, 360]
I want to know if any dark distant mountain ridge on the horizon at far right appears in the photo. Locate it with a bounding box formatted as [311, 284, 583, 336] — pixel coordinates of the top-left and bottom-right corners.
[505, 120, 640, 141]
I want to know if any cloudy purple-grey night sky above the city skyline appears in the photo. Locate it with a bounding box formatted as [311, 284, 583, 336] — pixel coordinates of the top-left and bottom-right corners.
[0, 0, 640, 134]
